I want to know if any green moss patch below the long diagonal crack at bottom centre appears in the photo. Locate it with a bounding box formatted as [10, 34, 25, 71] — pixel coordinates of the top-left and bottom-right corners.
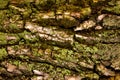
[34, 63, 72, 80]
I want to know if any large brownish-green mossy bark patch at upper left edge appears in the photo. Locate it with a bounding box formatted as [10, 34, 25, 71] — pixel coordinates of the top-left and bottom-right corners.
[0, 10, 23, 32]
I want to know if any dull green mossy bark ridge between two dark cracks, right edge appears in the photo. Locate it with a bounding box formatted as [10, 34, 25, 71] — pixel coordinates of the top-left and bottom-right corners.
[89, 29, 119, 43]
